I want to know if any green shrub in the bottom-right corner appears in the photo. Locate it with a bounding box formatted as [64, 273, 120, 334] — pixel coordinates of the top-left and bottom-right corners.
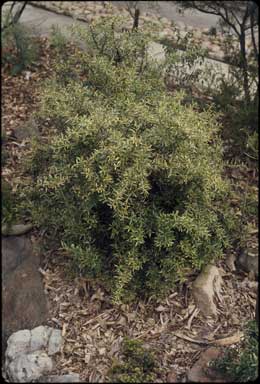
[212, 321, 259, 383]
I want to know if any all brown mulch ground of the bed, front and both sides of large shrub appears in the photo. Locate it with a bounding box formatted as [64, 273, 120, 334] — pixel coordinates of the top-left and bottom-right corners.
[2, 10, 257, 382]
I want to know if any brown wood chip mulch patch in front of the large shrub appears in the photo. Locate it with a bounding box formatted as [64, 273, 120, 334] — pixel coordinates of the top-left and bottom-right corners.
[40, 250, 257, 382]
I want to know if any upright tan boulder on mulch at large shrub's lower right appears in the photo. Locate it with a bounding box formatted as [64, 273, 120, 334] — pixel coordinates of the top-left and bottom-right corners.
[192, 264, 222, 317]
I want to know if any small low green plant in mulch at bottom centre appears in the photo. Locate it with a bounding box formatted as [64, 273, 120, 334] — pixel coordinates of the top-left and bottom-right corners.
[109, 338, 156, 383]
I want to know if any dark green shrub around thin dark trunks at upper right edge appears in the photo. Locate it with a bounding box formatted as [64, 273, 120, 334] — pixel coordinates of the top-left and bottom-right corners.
[209, 32, 259, 160]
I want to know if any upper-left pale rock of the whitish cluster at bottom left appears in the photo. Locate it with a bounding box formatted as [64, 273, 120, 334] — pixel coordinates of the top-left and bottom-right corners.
[5, 329, 31, 360]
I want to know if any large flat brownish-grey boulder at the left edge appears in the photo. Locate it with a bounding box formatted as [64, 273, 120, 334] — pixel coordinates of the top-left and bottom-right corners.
[2, 236, 48, 356]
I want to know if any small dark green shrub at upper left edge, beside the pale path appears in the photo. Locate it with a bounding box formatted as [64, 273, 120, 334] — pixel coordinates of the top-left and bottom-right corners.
[1, 23, 39, 75]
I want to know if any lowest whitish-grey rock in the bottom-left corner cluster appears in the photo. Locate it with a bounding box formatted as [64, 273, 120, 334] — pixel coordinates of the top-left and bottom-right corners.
[6, 351, 53, 383]
